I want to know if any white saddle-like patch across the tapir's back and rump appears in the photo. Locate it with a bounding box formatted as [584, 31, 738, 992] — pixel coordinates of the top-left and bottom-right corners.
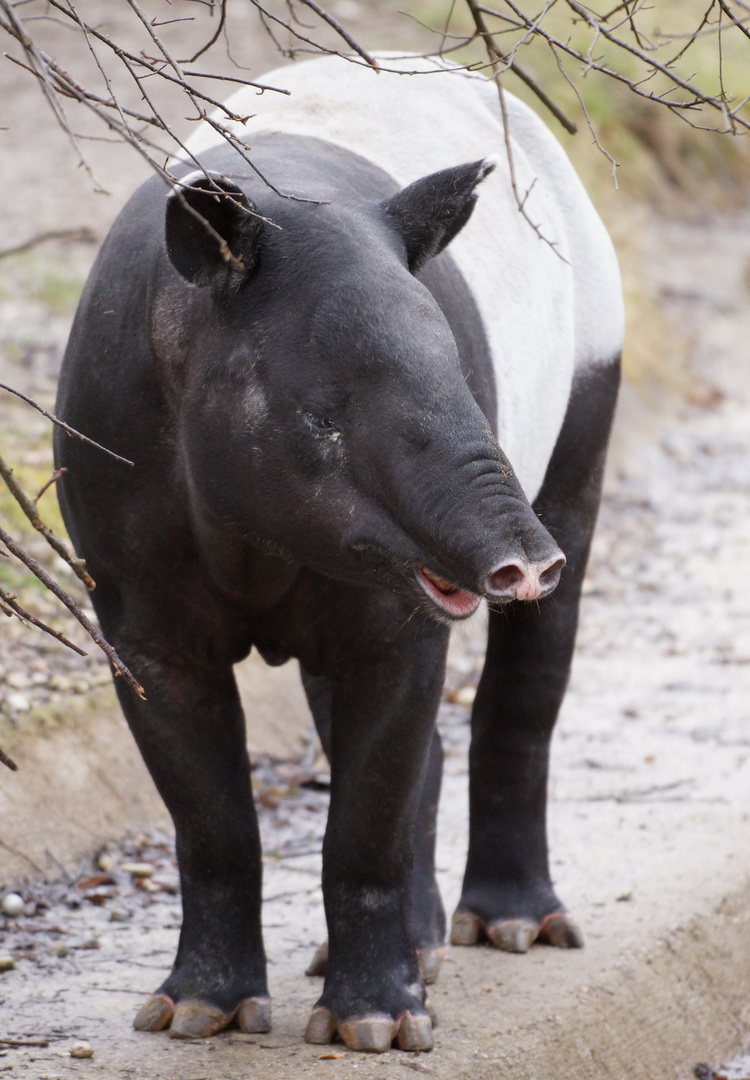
[184, 57, 622, 498]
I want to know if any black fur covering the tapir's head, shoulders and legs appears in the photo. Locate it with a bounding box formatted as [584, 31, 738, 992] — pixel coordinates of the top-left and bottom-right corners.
[56, 135, 618, 1045]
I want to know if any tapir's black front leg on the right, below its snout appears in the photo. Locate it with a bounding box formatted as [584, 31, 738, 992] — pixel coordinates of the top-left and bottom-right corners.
[306, 619, 447, 1051]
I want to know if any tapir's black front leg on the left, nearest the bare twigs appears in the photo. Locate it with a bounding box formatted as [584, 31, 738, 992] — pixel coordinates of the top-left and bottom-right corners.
[99, 618, 270, 1038]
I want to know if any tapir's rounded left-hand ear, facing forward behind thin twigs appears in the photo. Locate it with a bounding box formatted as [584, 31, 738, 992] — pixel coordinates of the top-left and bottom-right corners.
[165, 172, 263, 289]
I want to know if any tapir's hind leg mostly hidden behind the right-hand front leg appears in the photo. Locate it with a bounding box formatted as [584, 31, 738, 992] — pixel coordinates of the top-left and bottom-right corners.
[302, 671, 445, 985]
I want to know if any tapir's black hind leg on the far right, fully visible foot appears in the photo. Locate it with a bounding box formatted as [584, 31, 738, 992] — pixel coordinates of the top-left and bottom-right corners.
[451, 364, 619, 953]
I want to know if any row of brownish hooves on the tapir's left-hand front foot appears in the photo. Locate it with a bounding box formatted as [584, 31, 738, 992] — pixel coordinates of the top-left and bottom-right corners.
[133, 994, 271, 1039]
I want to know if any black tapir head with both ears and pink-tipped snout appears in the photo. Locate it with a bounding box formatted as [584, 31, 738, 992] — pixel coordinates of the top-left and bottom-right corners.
[159, 161, 565, 618]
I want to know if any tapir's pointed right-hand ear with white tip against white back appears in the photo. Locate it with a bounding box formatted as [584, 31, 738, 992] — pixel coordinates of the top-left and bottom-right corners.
[381, 158, 496, 273]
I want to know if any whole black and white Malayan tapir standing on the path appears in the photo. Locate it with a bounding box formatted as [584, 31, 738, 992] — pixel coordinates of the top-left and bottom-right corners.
[56, 57, 624, 1051]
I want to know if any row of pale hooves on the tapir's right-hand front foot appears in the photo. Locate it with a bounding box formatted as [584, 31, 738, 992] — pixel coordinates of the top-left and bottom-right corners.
[305, 1005, 432, 1054]
